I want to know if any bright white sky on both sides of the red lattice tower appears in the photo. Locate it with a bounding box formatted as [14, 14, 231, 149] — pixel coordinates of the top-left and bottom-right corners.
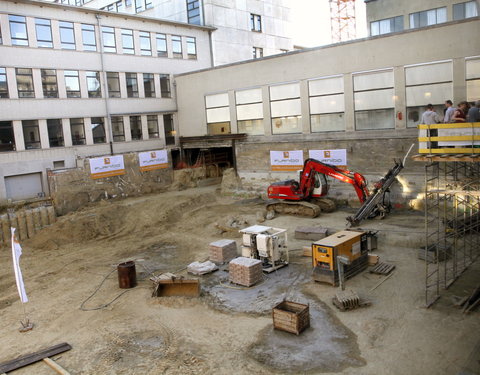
[290, 0, 367, 47]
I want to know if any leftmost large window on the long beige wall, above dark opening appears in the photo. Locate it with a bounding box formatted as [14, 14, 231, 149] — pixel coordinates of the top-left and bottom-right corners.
[205, 92, 230, 135]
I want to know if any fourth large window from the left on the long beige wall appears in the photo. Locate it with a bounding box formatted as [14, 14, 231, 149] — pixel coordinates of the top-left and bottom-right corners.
[308, 76, 345, 133]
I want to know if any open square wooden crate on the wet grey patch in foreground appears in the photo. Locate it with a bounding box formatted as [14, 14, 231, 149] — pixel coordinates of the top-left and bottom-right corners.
[272, 301, 310, 335]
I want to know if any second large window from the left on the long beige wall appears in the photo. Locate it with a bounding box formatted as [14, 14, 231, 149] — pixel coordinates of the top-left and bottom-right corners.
[235, 88, 265, 135]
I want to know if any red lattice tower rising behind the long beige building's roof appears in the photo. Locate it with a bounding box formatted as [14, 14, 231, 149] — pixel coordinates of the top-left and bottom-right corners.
[329, 0, 357, 43]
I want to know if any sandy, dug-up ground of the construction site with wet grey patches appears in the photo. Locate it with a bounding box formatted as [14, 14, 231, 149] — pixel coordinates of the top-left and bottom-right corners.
[0, 186, 480, 375]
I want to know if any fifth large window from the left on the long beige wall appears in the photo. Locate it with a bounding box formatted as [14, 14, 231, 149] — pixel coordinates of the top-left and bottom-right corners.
[353, 70, 395, 130]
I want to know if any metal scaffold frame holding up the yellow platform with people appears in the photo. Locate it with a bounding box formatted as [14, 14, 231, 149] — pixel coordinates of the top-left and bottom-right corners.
[424, 161, 480, 307]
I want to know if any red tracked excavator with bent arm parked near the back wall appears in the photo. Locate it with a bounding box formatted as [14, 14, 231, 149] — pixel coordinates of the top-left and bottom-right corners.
[267, 159, 370, 217]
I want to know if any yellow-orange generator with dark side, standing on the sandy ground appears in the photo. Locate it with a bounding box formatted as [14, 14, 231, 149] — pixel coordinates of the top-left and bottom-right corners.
[312, 230, 368, 286]
